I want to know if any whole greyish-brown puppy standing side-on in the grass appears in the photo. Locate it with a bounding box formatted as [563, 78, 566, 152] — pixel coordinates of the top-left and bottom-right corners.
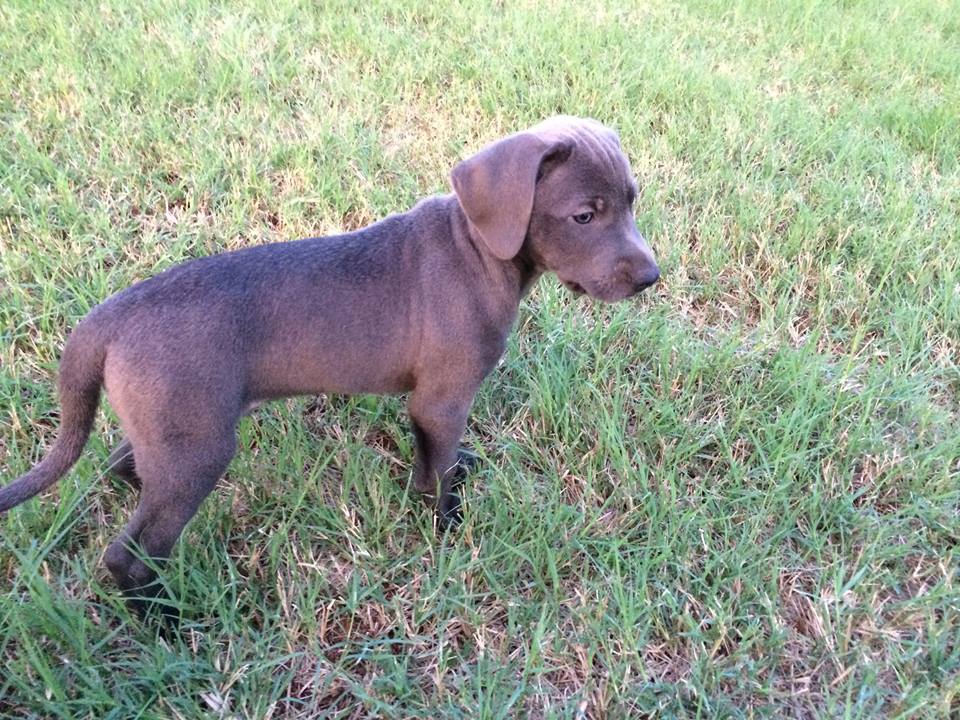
[0, 117, 659, 612]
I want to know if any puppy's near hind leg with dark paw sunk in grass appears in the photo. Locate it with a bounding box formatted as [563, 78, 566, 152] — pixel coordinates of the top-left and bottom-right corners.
[104, 428, 235, 618]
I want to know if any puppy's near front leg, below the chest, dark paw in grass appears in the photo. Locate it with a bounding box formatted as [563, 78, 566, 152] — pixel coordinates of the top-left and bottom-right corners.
[409, 385, 474, 528]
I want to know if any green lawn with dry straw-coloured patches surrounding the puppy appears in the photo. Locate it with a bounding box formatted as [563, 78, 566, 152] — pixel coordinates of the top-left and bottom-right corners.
[0, 0, 960, 719]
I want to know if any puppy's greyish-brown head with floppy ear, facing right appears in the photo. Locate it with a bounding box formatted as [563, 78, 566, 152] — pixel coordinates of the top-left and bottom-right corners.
[451, 116, 660, 302]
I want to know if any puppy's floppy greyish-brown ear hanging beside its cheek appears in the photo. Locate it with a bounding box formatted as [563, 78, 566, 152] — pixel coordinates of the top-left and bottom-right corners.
[450, 132, 573, 260]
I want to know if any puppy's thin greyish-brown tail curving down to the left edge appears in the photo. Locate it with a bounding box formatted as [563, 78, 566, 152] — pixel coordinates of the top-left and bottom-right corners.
[0, 322, 106, 512]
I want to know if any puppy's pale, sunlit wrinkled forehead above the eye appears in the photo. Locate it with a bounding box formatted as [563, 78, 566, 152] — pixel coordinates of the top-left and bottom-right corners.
[530, 116, 635, 192]
